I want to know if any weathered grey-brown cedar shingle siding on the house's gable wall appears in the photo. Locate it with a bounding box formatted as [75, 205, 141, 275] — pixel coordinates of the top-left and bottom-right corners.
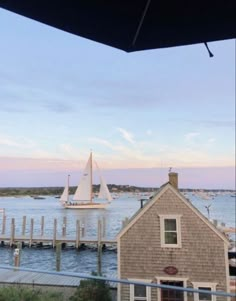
[119, 189, 227, 291]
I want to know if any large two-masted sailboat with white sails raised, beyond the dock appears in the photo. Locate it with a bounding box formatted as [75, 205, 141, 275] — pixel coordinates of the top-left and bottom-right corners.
[60, 153, 112, 209]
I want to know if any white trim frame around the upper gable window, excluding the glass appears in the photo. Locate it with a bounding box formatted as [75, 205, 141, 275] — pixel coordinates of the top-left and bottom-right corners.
[159, 214, 182, 248]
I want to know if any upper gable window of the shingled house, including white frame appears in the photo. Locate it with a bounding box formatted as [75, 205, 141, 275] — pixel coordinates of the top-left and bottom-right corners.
[160, 215, 181, 248]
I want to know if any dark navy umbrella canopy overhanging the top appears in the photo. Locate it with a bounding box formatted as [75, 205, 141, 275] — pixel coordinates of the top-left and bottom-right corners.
[0, 0, 236, 52]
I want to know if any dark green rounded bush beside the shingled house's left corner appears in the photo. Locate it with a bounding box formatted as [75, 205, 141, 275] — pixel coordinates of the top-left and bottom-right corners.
[69, 273, 112, 301]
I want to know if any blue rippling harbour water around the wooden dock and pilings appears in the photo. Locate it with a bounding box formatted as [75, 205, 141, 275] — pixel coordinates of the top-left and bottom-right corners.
[0, 193, 235, 277]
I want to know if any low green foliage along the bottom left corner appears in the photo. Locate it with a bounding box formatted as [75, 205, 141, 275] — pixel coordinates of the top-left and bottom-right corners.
[0, 286, 63, 301]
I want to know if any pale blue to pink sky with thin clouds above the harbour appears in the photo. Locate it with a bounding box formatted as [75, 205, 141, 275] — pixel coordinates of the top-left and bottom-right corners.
[0, 9, 235, 189]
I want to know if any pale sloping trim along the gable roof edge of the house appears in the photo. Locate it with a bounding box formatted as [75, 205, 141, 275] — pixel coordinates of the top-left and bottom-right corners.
[117, 182, 229, 245]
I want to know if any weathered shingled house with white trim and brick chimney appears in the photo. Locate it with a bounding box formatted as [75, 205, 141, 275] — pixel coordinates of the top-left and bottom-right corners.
[117, 172, 229, 301]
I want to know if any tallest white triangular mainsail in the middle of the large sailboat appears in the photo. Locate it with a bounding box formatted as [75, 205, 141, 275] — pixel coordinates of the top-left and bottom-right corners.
[73, 153, 92, 202]
